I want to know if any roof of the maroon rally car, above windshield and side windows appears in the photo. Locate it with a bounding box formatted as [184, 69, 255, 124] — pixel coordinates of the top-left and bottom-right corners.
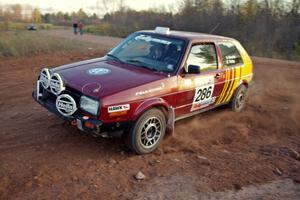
[138, 30, 235, 41]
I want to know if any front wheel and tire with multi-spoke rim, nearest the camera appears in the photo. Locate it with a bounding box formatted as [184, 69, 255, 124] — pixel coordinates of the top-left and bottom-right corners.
[125, 109, 167, 154]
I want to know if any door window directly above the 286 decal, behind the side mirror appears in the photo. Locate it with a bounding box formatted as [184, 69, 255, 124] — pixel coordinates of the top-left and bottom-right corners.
[186, 43, 218, 72]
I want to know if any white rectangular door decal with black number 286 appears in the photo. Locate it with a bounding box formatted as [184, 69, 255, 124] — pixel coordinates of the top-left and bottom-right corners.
[191, 76, 215, 111]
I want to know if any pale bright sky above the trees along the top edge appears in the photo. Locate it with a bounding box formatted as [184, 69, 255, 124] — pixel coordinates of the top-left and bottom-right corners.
[0, 0, 180, 13]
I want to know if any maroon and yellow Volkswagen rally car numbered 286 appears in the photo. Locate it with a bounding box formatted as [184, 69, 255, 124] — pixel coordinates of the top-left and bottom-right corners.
[33, 27, 253, 154]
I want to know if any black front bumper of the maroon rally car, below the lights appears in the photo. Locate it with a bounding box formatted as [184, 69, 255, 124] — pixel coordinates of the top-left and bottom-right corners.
[32, 90, 130, 137]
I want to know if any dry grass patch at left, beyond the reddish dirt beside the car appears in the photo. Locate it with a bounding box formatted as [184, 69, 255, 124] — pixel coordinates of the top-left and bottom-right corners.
[0, 31, 96, 57]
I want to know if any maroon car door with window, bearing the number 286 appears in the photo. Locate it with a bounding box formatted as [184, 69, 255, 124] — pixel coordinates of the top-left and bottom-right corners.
[175, 42, 225, 118]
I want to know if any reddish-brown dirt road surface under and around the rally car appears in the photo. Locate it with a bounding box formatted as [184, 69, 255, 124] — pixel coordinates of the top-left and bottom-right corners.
[0, 30, 300, 200]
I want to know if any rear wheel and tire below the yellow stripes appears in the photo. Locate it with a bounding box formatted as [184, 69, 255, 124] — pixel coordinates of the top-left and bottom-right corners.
[230, 85, 248, 112]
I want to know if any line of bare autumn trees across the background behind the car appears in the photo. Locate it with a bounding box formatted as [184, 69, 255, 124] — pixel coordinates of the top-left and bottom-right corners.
[0, 0, 300, 60]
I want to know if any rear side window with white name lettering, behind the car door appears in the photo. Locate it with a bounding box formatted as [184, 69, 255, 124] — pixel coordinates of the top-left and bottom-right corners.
[219, 42, 243, 67]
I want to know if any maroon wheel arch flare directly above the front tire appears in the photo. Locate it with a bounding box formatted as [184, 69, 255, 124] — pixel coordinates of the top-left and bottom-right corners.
[132, 98, 170, 121]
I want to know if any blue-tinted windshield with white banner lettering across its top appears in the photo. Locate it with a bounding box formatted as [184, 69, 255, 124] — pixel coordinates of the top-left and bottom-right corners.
[107, 33, 185, 73]
